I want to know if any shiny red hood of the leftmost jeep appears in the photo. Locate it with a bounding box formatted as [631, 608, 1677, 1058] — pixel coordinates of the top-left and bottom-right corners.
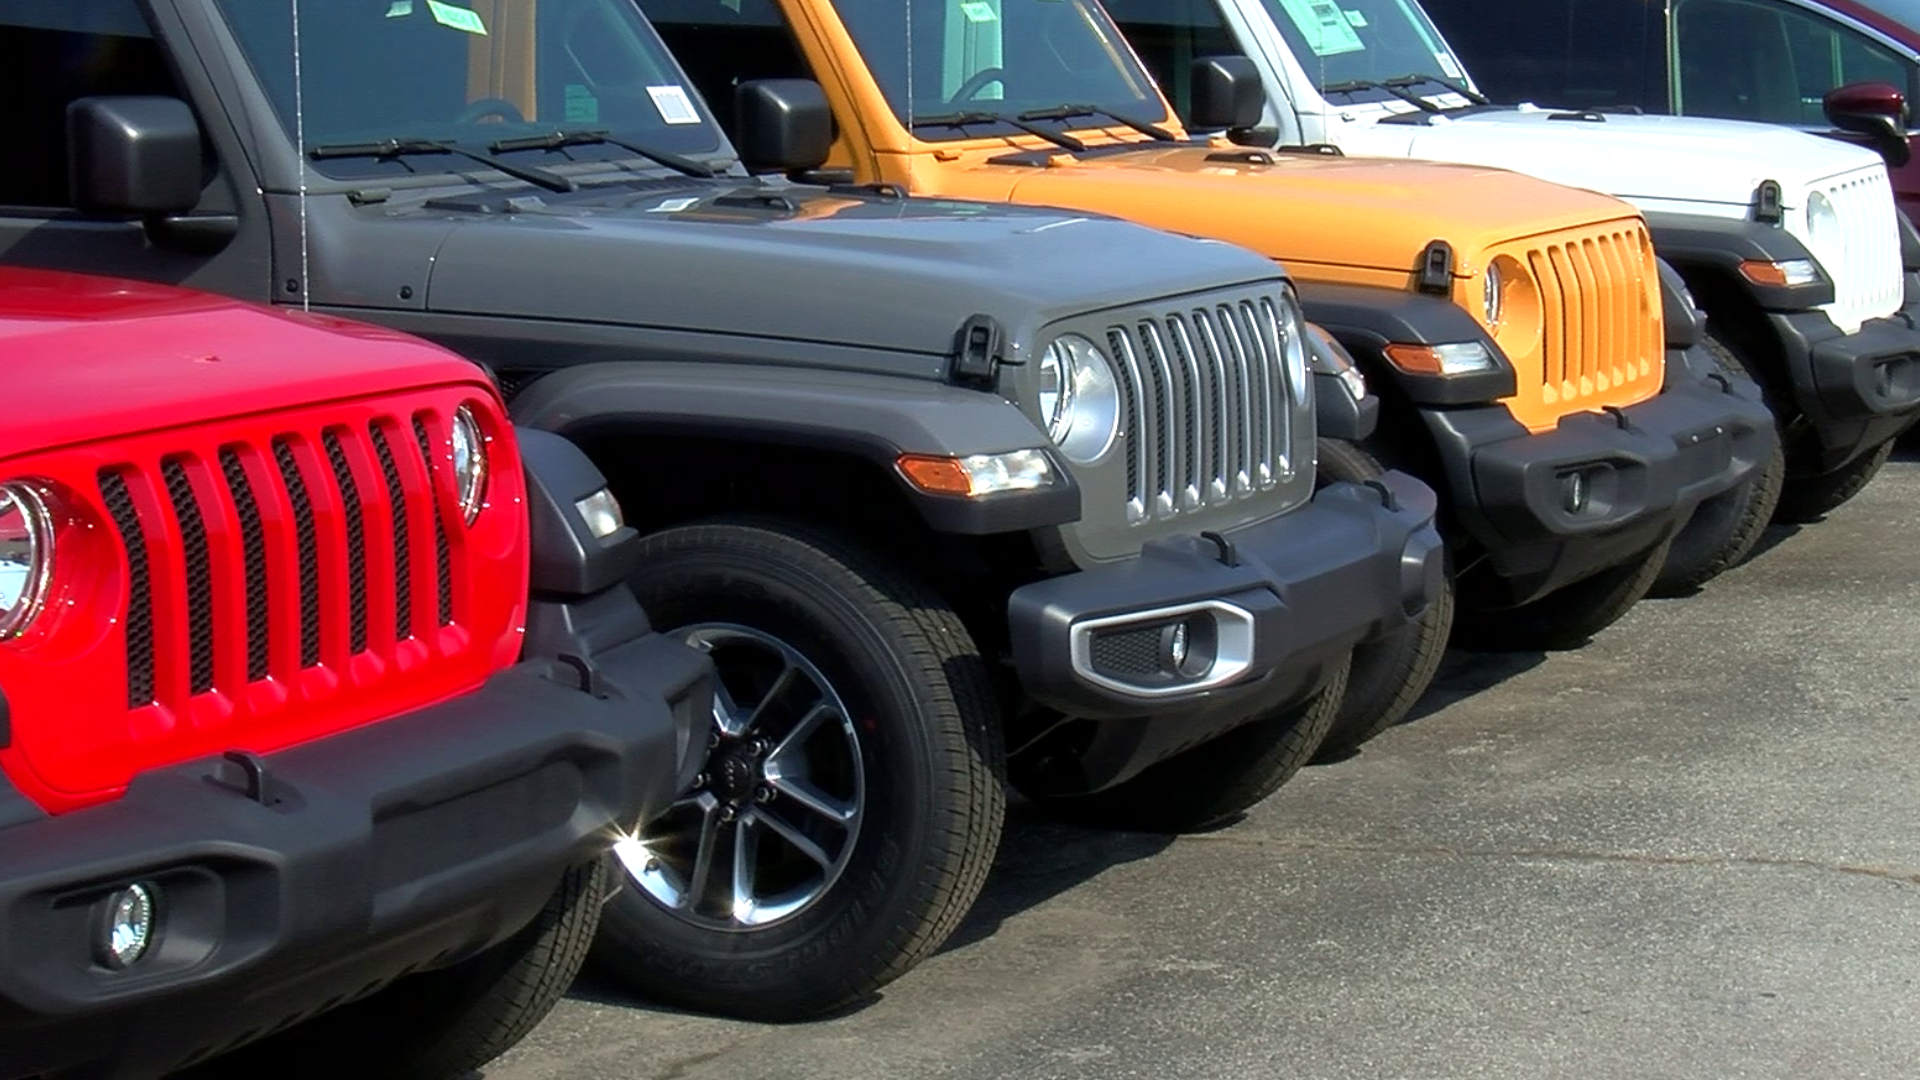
[0, 267, 480, 457]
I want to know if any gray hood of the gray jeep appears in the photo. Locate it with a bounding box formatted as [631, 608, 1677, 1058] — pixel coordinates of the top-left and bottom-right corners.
[426, 183, 1277, 356]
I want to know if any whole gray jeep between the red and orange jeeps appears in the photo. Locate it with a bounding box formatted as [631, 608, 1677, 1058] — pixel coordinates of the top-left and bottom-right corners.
[0, 0, 1440, 1019]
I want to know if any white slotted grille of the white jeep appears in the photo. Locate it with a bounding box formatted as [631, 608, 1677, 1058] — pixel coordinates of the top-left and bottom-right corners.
[1786, 165, 1905, 334]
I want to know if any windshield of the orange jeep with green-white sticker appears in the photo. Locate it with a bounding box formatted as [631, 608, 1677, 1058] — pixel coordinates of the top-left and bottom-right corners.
[833, 0, 1167, 140]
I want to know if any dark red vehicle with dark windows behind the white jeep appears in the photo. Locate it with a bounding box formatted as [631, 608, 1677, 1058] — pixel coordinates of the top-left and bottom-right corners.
[1425, 0, 1920, 213]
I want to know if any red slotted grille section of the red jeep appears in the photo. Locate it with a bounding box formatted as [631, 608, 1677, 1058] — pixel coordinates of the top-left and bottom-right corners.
[100, 415, 455, 709]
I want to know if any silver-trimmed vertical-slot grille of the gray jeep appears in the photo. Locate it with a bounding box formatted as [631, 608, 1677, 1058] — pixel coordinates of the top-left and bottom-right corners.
[1106, 296, 1294, 525]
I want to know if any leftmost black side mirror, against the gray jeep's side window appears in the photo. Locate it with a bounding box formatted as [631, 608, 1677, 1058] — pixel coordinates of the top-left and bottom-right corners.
[67, 98, 202, 217]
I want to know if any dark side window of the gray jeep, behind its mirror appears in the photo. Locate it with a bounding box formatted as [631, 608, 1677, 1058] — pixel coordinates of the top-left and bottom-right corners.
[0, 0, 179, 209]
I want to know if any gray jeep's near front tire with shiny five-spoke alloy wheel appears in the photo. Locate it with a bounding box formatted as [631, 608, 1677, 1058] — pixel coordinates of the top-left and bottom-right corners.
[595, 523, 1006, 1020]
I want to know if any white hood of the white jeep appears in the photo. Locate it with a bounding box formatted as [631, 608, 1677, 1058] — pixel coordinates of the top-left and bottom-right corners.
[1340, 106, 1880, 209]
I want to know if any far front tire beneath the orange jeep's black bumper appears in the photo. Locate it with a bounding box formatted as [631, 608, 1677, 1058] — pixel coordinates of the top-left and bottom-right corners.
[1453, 540, 1672, 651]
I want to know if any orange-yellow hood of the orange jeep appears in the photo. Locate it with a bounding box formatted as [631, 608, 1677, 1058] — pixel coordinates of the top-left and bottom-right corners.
[929, 146, 1634, 277]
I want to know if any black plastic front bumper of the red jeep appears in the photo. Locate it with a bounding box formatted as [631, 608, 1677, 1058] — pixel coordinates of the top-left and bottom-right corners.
[0, 618, 710, 1080]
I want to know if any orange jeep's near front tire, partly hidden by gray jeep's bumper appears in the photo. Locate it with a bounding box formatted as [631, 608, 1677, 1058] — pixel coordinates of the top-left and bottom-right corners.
[1313, 438, 1453, 761]
